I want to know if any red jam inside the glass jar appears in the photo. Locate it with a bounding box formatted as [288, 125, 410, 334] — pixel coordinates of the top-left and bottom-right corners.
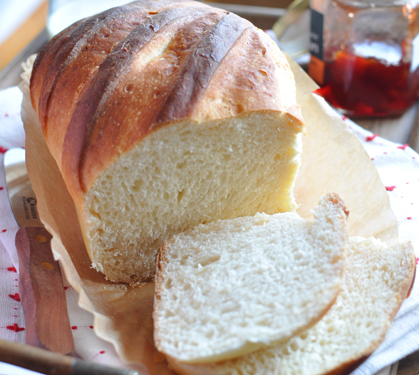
[315, 49, 419, 117]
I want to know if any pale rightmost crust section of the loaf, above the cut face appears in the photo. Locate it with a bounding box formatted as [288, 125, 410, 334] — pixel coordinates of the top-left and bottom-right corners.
[189, 25, 301, 123]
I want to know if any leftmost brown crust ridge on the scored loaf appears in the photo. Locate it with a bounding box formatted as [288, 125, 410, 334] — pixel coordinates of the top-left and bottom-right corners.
[34, 1, 206, 168]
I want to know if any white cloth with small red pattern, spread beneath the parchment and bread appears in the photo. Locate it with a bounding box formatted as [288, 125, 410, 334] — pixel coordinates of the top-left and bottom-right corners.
[0, 87, 419, 375]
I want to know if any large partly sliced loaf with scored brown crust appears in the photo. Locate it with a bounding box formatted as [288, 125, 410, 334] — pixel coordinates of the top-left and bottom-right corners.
[28, 0, 304, 283]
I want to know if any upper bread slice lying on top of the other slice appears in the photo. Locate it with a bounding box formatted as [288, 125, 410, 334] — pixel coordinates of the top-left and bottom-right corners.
[153, 194, 347, 363]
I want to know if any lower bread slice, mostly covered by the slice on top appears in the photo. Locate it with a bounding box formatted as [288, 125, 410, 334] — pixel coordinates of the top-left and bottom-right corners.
[169, 238, 415, 375]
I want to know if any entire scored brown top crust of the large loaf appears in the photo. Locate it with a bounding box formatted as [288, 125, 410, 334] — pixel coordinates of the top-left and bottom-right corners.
[31, 1, 303, 206]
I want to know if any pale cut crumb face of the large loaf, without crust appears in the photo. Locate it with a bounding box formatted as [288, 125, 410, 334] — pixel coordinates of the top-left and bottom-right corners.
[80, 113, 300, 280]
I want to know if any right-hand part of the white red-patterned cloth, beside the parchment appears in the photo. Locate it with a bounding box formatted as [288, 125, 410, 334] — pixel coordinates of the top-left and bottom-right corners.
[345, 115, 419, 375]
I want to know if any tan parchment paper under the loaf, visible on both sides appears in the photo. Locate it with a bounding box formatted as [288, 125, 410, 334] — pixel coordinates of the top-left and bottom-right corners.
[21, 54, 397, 375]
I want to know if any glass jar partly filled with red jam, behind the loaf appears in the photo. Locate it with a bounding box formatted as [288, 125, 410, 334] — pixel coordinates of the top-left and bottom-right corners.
[309, 0, 419, 117]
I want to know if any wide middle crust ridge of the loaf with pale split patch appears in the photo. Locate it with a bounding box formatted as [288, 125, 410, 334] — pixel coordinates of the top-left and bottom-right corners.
[63, 7, 225, 203]
